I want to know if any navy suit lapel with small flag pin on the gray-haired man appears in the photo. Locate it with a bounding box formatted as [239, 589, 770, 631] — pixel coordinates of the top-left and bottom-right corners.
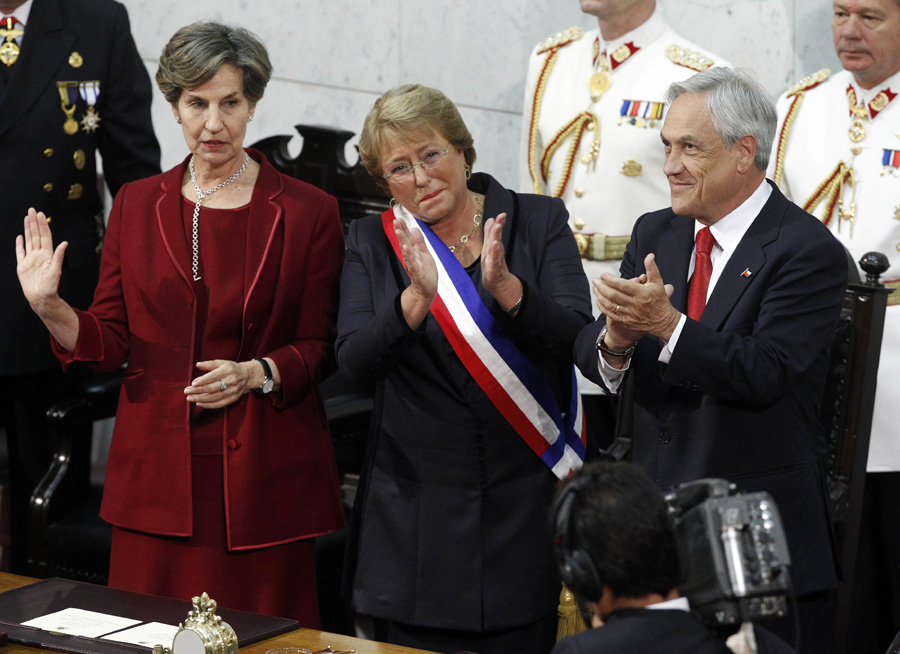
[700, 183, 787, 329]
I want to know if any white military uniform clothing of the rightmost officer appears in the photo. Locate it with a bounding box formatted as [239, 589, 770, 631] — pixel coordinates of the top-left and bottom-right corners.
[769, 69, 900, 472]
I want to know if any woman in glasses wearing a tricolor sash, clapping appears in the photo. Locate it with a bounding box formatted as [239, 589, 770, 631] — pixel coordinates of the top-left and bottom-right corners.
[336, 85, 591, 654]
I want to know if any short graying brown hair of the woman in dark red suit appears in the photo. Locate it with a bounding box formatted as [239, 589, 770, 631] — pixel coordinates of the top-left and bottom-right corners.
[156, 21, 272, 105]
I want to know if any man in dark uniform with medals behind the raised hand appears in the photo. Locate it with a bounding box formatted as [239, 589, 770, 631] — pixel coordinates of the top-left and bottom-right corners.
[0, 0, 160, 571]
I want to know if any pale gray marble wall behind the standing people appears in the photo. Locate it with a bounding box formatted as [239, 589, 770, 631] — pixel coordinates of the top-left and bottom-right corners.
[122, 0, 839, 192]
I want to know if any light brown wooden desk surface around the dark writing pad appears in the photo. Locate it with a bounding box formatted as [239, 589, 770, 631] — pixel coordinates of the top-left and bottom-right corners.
[0, 572, 429, 654]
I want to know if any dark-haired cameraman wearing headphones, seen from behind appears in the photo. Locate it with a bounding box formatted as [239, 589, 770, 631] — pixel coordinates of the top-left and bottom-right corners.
[552, 462, 794, 654]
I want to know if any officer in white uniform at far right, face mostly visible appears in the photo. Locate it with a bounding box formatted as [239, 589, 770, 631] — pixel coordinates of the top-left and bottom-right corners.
[769, 0, 900, 651]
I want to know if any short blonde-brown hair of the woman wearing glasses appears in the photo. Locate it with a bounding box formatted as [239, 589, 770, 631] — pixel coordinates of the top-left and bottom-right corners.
[359, 84, 475, 190]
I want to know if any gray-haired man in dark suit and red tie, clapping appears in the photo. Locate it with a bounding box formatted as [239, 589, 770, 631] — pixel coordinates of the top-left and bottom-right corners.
[576, 68, 847, 651]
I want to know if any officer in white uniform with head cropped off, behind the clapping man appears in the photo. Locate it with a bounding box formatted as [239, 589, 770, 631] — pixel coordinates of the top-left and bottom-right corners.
[519, 0, 728, 444]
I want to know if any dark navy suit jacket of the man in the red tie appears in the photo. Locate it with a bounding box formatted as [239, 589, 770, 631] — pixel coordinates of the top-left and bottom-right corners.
[575, 185, 847, 593]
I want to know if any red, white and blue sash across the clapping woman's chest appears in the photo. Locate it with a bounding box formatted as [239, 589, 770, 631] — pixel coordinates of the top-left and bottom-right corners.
[381, 205, 585, 479]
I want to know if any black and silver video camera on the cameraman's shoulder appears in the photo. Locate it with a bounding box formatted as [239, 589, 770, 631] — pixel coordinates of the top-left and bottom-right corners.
[666, 479, 791, 625]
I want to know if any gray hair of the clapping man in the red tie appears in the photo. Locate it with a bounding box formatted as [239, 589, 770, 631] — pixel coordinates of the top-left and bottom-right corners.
[666, 66, 778, 172]
